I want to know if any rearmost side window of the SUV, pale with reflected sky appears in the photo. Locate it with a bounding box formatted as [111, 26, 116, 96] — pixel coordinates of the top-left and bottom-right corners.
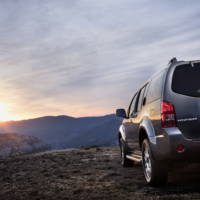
[146, 72, 164, 103]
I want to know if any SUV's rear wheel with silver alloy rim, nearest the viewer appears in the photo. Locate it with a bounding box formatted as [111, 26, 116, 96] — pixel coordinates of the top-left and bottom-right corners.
[142, 139, 168, 186]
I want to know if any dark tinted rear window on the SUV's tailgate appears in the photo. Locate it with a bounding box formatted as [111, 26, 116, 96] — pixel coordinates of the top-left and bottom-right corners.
[172, 63, 200, 97]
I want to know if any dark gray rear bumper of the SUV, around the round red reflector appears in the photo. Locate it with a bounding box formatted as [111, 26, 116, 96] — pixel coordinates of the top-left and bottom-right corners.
[152, 128, 200, 162]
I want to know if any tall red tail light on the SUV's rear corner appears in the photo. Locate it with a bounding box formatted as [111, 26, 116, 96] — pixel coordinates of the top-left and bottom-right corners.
[161, 101, 176, 128]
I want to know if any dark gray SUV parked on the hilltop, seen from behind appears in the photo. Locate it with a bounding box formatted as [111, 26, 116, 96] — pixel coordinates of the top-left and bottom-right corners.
[116, 58, 200, 185]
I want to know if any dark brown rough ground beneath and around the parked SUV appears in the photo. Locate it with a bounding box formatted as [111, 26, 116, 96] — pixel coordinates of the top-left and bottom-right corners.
[0, 147, 200, 200]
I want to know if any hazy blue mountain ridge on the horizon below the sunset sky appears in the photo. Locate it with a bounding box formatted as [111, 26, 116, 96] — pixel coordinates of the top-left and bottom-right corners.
[0, 114, 121, 149]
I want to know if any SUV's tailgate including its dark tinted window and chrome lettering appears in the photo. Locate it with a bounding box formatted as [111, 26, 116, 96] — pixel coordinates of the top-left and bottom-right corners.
[171, 63, 200, 140]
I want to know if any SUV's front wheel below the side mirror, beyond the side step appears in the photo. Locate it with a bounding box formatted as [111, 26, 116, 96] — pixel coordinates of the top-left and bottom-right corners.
[119, 138, 134, 167]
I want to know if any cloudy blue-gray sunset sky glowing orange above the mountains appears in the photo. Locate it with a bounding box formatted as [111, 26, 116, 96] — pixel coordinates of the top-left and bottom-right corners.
[0, 0, 200, 120]
